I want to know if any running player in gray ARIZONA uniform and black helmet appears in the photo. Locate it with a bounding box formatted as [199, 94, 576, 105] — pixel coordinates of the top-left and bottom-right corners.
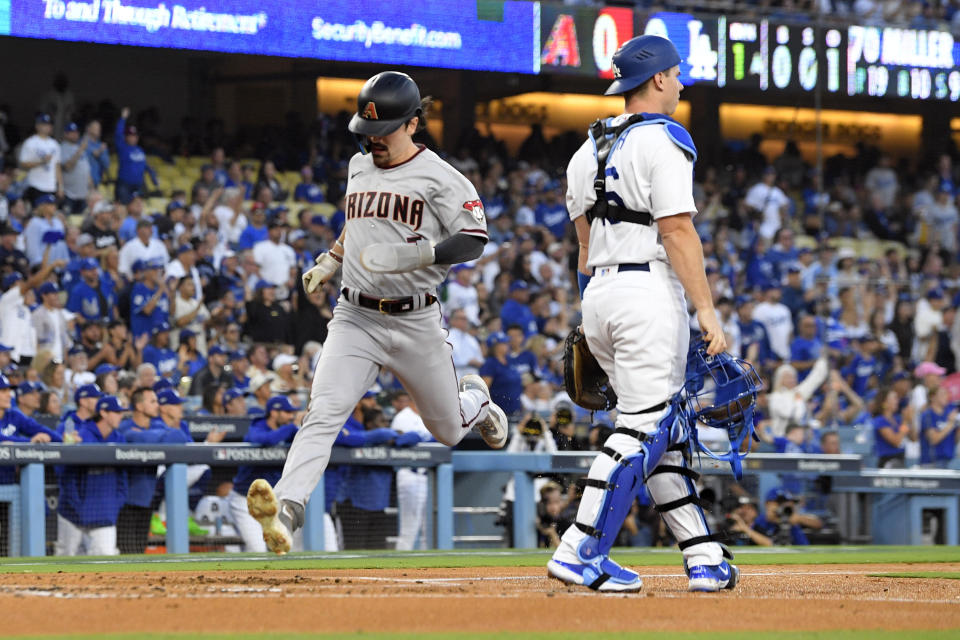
[247, 71, 507, 554]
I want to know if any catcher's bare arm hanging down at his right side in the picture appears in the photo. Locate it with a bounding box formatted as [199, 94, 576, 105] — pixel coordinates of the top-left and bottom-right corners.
[657, 213, 727, 355]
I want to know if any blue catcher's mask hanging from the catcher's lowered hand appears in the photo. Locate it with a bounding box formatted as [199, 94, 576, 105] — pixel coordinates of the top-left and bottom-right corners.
[683, 338, 763, 480]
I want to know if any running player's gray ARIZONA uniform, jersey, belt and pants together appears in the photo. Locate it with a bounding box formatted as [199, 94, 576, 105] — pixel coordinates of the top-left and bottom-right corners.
[274, 147, 489, 504]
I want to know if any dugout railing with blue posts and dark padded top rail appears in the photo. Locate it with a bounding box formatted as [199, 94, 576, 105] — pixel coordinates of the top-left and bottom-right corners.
[0, 450, 960, 556]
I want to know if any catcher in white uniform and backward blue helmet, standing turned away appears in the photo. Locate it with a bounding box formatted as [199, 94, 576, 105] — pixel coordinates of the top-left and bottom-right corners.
[548, 35, 738, 591]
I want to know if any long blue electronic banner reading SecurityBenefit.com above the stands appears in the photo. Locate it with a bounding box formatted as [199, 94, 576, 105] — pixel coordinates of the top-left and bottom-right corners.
[0, 0, 539, 73]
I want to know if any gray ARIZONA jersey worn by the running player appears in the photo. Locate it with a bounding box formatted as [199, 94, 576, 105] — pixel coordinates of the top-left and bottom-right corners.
[343, 147, 487, 298]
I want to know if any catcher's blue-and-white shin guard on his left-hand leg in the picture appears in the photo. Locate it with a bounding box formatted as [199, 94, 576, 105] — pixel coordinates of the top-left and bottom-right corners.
[575, 403, 682, 561]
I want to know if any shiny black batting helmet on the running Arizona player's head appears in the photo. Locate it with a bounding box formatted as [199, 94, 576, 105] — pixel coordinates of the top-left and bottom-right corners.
[348, 71, 421, 137]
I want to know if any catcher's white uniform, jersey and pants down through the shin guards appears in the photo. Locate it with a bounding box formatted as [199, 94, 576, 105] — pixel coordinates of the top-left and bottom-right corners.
[554, 114, 722, 566]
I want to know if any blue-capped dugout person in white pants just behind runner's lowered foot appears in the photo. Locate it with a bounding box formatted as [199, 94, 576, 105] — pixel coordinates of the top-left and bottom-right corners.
[227, 396, 300, 553]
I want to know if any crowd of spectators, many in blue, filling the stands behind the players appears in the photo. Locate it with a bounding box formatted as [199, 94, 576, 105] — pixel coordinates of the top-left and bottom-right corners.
[0, 79, 960, 552]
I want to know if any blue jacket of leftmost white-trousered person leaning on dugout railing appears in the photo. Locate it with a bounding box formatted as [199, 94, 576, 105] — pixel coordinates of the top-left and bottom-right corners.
[57, 422, 128, 527]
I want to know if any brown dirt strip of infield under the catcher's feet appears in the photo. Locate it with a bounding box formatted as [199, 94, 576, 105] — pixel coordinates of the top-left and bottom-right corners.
[0, 563, 960, 635]
